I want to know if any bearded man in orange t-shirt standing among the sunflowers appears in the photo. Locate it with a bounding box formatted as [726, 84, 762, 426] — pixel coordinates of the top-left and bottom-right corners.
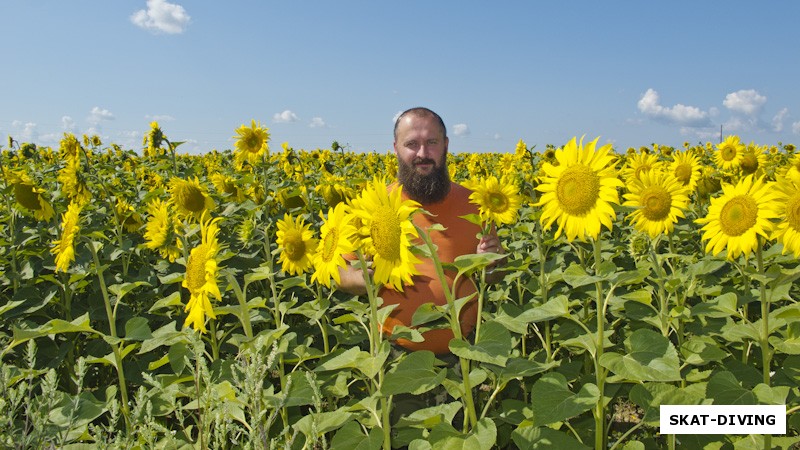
[339, 107, 503, 355]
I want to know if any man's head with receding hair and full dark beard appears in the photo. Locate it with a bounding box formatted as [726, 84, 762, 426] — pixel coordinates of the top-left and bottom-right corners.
[394, 107, 450, 204]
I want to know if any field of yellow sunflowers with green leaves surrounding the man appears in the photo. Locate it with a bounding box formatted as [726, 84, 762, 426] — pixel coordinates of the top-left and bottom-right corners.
[0, 121, 800, 450]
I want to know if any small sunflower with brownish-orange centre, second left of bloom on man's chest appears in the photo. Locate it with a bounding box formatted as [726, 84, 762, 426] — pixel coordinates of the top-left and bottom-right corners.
[276, 214, 317, 275]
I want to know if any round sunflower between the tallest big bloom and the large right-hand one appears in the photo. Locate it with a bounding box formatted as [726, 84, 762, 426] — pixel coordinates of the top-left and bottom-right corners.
[623, 171, 689, 239]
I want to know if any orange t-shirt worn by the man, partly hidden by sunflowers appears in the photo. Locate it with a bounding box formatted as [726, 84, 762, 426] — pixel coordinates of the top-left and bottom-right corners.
[379, 182, 481, 354]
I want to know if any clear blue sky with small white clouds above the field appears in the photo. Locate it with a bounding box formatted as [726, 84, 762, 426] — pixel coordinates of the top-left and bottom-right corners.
[0, 0, 800, 153]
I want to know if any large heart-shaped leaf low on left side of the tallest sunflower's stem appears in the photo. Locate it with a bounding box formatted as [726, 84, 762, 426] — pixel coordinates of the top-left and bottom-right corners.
[530, 372, 600, 427]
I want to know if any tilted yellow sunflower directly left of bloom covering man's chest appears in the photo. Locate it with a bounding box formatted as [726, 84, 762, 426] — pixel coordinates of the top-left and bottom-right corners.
[311, 203, 357, 287]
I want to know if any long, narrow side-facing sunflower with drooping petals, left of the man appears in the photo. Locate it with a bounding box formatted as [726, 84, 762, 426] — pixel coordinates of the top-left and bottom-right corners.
[182, 215, 222, 333]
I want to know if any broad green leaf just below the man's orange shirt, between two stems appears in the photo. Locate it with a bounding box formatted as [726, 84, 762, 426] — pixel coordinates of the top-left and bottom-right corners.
[381, 350, 446, 395]
